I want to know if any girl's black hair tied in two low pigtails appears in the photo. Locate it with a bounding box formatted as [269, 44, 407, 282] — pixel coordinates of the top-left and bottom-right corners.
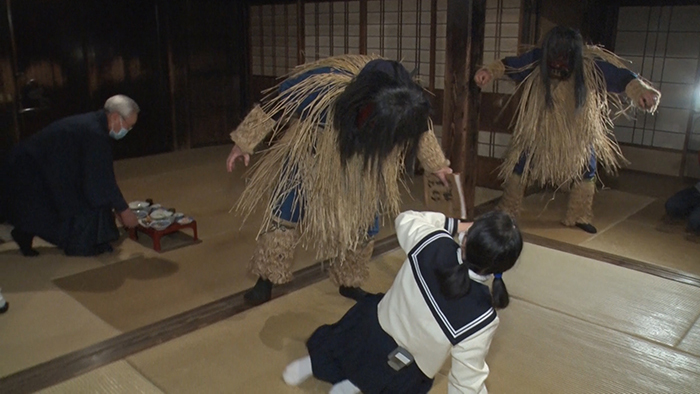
[436, 210, 523, 308]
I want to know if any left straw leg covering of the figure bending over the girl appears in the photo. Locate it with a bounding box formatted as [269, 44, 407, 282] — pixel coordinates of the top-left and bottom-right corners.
[249, 225, 300, 285]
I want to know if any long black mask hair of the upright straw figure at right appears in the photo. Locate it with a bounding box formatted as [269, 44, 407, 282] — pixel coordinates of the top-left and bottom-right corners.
[540, 26, 586, 108]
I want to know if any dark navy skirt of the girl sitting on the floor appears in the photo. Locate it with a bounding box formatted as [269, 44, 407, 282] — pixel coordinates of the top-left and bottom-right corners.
[306, 294, 433, 394]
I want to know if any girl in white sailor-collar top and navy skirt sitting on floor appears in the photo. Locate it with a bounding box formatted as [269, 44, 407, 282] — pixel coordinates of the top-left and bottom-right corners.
[283, 211, 523, 394]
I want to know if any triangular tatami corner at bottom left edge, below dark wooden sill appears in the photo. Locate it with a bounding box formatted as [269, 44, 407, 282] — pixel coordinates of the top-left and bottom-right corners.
[37, 360, 163, 394]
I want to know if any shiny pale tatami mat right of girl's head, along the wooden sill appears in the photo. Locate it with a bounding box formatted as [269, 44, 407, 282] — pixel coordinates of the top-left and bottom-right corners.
[503, 244, 700, 346]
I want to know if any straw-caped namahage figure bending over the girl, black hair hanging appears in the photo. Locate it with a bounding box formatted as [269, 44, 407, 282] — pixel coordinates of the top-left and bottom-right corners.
[227, 55, 452, 304]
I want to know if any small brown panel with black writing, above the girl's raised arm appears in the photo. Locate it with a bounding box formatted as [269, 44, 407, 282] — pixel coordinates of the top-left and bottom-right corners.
[423, 174, 467, 219]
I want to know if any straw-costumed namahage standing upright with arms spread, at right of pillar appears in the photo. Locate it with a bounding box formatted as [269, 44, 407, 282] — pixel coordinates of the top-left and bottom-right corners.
[474, 26, 661, 233]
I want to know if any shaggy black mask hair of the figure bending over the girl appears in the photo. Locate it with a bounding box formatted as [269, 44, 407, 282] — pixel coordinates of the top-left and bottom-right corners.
[333, 59, 430, 169]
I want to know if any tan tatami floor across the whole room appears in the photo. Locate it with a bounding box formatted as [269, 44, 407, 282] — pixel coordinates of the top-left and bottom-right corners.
[0, 147, 700, 393]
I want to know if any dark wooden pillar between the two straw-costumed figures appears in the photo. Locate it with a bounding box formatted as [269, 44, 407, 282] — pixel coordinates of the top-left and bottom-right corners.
[442, 0, 486, 219]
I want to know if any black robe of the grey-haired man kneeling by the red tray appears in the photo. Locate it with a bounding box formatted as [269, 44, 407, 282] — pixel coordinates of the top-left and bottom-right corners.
[0, 111, 128, 256]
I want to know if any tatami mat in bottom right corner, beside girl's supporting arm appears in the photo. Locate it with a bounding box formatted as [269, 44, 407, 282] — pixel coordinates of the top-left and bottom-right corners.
[487, 295, 700, 394]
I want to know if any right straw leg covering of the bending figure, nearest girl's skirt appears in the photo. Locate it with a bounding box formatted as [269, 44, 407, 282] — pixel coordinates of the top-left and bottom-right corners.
[328, 239, 374, 287]
